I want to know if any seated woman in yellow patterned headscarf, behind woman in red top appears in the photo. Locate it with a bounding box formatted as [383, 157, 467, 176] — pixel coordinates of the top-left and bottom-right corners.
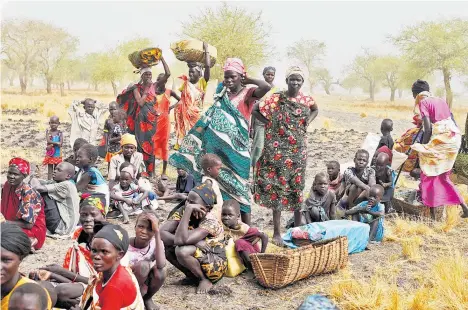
[29, 196, 111, 309]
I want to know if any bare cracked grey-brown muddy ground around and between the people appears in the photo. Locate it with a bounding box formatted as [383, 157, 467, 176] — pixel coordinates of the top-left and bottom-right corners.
[1, 107, 468, 310]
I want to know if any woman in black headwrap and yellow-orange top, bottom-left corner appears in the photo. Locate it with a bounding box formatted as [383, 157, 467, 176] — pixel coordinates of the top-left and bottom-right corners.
[0, 222, 52, 310]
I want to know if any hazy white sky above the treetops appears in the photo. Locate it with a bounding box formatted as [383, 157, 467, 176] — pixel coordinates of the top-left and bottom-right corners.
[2, 1, 468, 91]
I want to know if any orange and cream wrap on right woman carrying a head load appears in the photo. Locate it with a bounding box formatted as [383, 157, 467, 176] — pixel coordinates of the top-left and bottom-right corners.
[174, 75, 208, 149]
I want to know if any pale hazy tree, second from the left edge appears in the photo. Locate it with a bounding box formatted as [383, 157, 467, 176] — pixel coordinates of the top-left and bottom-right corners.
[38, 24, 78, 95]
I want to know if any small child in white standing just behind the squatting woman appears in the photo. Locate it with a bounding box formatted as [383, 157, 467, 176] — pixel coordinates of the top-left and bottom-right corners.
[201, 154, 223, 221]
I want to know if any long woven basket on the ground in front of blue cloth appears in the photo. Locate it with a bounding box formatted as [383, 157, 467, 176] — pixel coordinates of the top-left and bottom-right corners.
[250, 237, 348, 288]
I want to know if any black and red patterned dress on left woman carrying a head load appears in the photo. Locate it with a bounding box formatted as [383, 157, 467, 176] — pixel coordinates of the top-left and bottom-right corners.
[116, 84, 157, 173]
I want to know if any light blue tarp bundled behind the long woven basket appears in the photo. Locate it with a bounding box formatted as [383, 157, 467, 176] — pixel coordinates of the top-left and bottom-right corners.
[283, 220, 370, 254]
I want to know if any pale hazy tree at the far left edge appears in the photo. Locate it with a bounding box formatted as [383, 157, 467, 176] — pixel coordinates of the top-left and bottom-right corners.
[1, 20, 45, 94]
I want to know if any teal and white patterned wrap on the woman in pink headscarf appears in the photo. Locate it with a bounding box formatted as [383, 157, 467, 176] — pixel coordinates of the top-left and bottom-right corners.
[169, 84, 250, 213]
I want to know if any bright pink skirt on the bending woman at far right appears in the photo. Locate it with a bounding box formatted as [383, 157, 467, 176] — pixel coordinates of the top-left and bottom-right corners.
[419, 171, 463, 208]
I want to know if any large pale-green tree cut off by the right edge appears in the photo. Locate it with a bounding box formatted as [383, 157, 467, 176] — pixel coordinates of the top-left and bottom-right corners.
[392, 19, 468, 107]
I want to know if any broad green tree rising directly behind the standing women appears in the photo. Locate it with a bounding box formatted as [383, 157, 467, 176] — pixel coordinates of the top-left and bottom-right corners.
[180, 2, 271, 80]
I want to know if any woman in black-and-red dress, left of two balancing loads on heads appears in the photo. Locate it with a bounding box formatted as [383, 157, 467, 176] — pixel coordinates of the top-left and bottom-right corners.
[116, 56, 169, 176]
